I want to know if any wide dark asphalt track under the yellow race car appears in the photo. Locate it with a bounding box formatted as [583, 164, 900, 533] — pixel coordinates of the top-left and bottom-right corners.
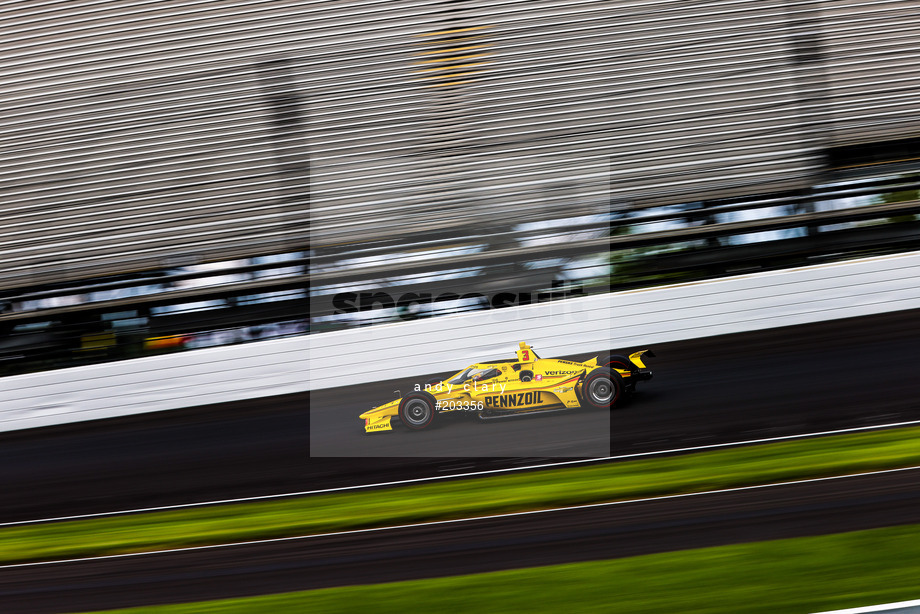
[0, 311, 920, 521]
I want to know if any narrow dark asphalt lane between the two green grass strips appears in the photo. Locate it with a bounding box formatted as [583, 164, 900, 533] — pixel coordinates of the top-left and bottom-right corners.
[0, 469, 920, 614]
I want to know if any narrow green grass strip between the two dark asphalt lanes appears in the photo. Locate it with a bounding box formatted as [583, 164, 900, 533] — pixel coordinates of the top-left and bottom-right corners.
[0, 428, 920, 563]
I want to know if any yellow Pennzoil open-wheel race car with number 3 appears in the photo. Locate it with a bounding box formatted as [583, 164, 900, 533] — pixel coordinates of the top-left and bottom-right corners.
[360, 341, 655, 433]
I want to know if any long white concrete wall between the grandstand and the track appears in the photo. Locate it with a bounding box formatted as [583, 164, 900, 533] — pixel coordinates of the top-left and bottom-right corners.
[0, 252, 920, 431]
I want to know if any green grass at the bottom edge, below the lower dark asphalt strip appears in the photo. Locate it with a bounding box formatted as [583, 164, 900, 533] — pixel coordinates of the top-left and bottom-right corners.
[81, 525, 920, 614]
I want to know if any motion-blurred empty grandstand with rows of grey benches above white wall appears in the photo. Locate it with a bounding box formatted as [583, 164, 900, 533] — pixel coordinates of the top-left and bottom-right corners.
[0, 0, 920, 374]
